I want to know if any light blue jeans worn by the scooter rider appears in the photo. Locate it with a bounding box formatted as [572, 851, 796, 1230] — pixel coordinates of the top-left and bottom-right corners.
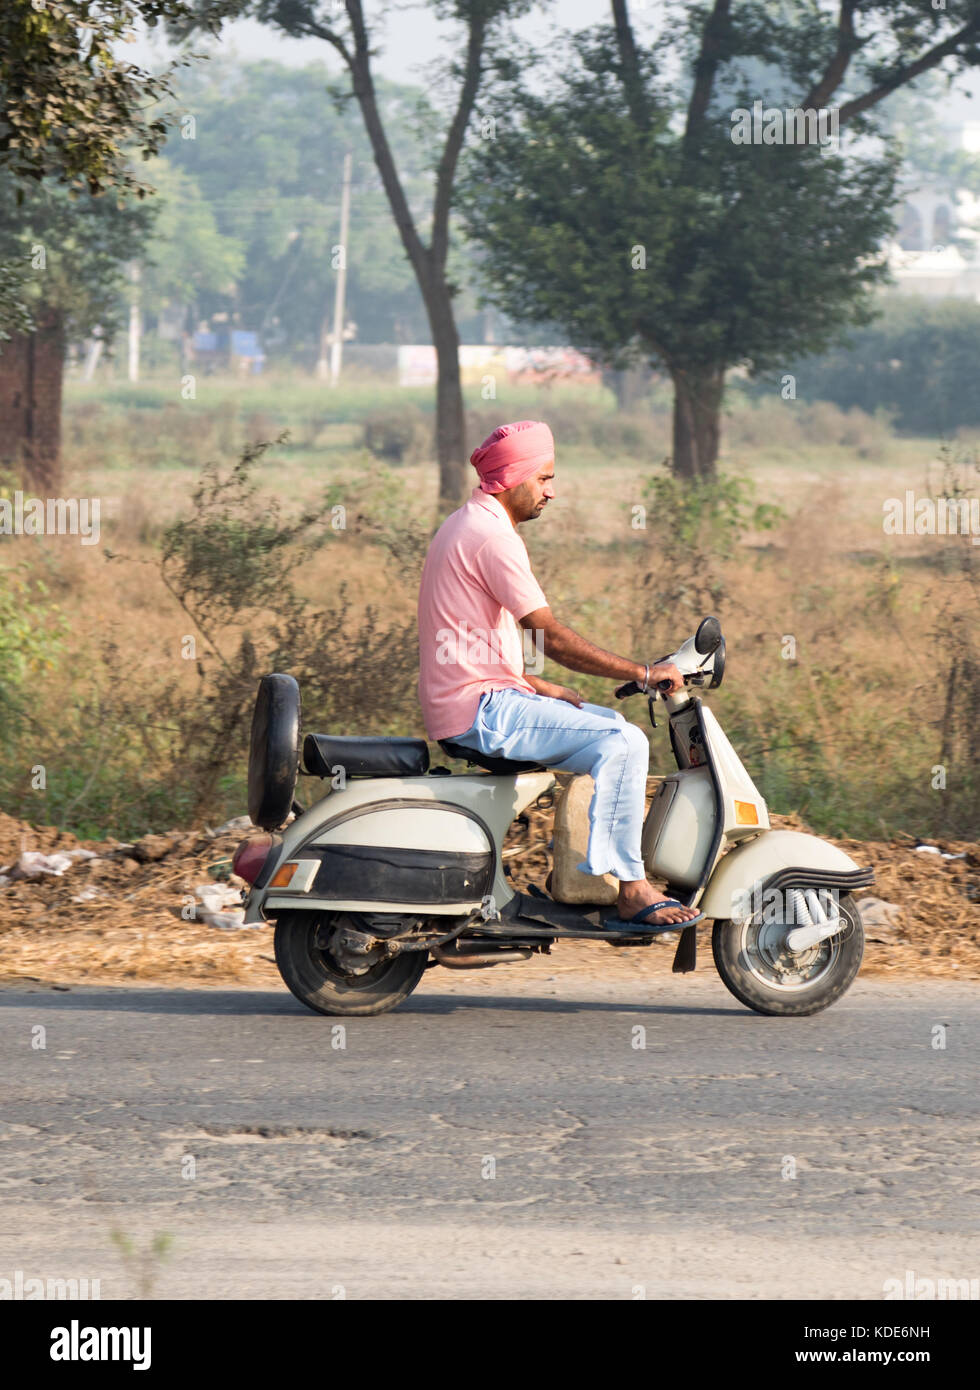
[452, 689, 651, 880]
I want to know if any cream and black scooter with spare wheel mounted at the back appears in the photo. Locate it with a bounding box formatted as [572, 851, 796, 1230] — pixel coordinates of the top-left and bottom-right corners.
[234, 617, 873, 1015]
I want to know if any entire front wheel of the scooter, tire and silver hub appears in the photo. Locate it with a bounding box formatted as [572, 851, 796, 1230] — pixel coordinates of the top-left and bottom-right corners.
[712, 894, 865, 1016]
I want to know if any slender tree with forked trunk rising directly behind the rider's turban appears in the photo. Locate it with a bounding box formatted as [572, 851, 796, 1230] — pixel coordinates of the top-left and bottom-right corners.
[182, 0, 531, 510]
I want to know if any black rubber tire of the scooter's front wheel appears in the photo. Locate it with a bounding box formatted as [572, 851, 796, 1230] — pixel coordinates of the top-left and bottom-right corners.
[712, 894, 865, 1017]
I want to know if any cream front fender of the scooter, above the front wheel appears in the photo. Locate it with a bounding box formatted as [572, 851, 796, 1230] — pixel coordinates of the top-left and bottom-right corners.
[698, 830, 874, 922]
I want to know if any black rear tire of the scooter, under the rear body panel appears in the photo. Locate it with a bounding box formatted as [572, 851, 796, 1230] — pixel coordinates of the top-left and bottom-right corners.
[274, 912, 428, 1017]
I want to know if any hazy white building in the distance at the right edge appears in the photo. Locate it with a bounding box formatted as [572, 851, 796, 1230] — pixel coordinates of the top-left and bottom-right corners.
[888, 121, 980, 302]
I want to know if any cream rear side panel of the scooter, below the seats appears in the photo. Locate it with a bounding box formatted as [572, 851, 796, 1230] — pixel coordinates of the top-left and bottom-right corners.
[245, 771, 555, 922]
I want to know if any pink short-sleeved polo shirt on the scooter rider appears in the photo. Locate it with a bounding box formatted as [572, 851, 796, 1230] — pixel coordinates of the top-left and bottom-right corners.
[418, 488, 548, 738]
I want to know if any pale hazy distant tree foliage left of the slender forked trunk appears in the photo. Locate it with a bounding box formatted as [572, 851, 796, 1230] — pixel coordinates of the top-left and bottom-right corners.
[160, 57, 453, 348]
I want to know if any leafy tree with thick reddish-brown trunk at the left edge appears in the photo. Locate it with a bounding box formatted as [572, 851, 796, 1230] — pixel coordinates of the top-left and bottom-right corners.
[0, 0, 212, 485]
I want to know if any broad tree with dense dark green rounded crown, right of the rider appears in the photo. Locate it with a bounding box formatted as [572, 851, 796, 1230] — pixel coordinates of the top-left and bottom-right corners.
[463, 0, 980, 478]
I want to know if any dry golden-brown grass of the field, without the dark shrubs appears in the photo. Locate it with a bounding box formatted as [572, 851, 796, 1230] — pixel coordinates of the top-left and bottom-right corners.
[0, 384, 980, 838]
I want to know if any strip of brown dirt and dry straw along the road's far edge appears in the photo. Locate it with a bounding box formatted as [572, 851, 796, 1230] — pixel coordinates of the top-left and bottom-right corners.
[0, 789, 980, 987]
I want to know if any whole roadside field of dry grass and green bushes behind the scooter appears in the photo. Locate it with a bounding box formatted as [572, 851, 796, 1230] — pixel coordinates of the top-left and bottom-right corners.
[0, 378, 980, 838]
